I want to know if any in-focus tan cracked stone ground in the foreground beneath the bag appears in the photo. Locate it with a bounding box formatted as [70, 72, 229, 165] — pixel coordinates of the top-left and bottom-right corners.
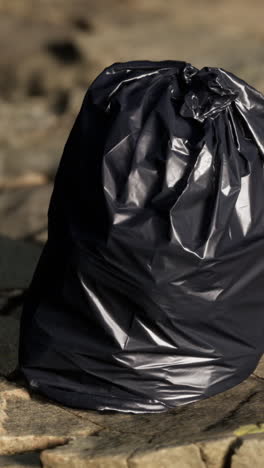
[0, 298, 264, 468]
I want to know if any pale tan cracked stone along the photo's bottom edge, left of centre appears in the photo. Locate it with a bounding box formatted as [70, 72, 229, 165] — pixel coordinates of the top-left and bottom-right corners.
[41, 434, 205, 468]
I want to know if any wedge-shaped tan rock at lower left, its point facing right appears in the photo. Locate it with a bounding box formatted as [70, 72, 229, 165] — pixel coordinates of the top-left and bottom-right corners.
[0, 379, 98, 455]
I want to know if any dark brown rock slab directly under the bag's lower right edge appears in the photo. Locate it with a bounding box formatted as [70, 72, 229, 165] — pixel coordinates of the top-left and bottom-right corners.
[66, 377, 264, 447]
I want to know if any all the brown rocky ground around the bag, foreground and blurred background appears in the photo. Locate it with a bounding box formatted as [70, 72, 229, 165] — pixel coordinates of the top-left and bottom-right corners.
[0, 0, 264, 468]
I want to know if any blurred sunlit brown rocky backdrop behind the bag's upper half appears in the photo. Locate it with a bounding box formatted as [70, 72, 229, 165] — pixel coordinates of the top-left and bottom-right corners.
[0, 0, 264, 249]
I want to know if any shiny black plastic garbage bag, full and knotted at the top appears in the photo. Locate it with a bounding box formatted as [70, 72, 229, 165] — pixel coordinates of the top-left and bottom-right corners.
[19, 61, 264, 413]
